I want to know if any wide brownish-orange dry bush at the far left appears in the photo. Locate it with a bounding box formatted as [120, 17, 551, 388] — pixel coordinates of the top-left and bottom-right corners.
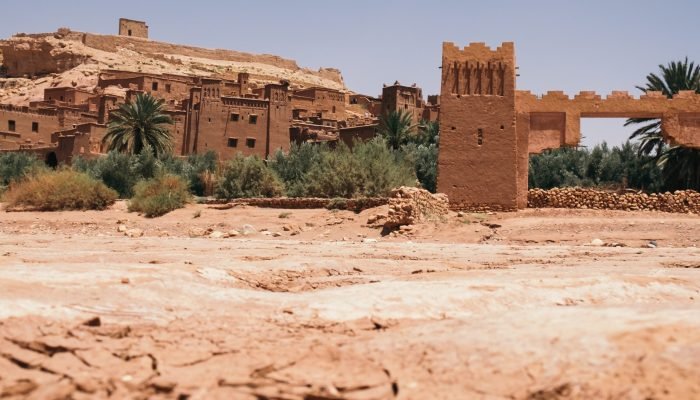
[4, 170, 117, 211]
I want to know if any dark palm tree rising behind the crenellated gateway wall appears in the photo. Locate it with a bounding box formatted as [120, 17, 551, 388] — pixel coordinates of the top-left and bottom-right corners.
[625, 57, 700, 190]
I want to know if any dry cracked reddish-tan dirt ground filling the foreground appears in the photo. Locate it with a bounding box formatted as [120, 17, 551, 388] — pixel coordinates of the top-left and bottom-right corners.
[0, 202, 700, 399]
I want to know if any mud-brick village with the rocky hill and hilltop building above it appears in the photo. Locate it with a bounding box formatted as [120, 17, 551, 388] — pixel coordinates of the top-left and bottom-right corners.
[0, 18, 439, 166]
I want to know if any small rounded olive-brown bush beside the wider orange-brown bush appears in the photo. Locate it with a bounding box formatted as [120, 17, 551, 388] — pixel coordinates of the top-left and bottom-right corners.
[129, 175, 190, 218]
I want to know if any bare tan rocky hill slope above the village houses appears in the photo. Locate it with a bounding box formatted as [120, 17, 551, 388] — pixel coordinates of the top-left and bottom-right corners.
[0, 28, 345, 105]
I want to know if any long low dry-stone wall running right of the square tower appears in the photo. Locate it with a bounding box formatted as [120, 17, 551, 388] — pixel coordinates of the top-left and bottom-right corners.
[527, 188, 700, 213]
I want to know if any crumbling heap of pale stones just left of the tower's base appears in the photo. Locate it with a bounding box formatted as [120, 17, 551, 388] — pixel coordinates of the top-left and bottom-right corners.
[367, 186, 449, 230]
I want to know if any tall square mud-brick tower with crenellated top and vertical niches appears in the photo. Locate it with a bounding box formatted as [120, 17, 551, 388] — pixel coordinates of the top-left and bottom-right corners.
[438, 43, 519, 209]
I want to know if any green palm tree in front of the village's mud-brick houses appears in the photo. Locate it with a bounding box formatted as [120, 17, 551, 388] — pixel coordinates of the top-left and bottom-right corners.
[102, 93, 173, 156]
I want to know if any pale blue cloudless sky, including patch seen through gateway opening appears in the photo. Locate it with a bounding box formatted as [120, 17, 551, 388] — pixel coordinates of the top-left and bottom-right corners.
[0, 0, 700, 146]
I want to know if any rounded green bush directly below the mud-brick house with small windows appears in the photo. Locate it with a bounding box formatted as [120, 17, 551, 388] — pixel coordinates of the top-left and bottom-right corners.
[215, 154, 283, 200]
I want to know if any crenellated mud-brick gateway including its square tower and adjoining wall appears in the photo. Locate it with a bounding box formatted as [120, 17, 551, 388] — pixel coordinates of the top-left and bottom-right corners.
[438, 42, 700, 210]
